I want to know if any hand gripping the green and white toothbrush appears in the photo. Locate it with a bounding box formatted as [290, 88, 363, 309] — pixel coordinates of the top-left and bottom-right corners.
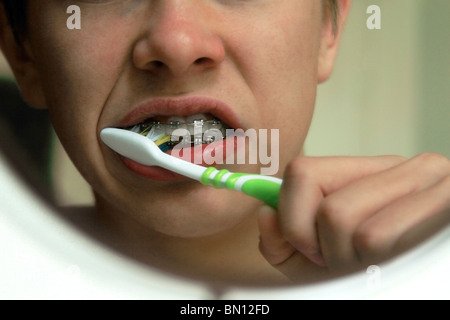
[259, 154, 450, 282]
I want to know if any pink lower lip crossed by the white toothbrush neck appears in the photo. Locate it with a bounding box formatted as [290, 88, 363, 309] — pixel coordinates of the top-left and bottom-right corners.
[121, 137, 243, 181]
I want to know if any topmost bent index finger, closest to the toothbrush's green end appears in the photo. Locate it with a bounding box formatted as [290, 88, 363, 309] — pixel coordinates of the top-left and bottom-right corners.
[279, 157, 405, 266]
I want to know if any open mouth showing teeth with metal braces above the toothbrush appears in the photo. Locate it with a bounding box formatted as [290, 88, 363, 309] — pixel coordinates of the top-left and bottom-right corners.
[125, 113, 231, 152]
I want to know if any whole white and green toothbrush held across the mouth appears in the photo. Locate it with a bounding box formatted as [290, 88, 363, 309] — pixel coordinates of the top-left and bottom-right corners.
[100, 128, 283, 209]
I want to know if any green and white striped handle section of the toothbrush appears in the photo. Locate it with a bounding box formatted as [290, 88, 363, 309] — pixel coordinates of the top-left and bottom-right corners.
[202, 167, 283, 209]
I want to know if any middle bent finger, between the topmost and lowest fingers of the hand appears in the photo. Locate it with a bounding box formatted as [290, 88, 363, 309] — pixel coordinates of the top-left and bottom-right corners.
[317, 155, 450, 268]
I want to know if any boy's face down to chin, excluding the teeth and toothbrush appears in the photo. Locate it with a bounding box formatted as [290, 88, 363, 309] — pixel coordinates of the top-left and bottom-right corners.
[20, 0, 338, 236]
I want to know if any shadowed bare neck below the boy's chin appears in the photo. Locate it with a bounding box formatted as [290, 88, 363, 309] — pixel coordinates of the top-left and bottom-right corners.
[90, 197, 287, 287]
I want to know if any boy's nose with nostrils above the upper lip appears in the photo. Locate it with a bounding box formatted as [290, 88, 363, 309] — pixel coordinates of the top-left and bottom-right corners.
[133, 0, 225, 76]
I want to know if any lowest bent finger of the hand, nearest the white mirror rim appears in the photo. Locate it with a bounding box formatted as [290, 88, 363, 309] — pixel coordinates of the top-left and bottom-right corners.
[353, 172, 450, 265]
